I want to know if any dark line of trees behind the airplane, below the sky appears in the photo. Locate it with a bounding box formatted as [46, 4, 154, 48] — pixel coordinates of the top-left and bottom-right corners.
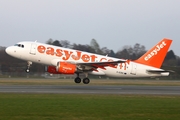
[0, 39, 180, 76]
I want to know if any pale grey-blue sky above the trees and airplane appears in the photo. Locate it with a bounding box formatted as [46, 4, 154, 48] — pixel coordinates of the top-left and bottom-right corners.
[0, 0, 180, 56]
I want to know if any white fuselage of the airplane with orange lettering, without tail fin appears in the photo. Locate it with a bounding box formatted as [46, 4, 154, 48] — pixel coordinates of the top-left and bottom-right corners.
[6, 42, 169, 78]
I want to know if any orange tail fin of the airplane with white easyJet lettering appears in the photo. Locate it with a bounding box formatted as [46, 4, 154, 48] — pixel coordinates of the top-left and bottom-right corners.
[135, 38, 172, 68]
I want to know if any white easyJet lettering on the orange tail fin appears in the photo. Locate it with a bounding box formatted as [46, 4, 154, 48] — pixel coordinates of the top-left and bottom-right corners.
[144, 41, 166, 61]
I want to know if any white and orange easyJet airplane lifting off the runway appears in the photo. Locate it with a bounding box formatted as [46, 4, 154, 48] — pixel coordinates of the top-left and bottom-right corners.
[5, 38, 172, 84]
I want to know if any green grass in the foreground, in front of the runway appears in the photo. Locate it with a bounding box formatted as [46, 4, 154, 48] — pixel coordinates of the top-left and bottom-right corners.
[0, 93, 180, 120]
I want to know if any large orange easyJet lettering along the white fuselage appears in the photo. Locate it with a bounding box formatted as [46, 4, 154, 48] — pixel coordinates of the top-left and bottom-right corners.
[37, 45, 113, 62]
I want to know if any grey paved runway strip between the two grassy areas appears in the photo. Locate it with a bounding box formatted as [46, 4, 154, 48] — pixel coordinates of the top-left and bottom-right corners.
[0, 85, 180, 95]
